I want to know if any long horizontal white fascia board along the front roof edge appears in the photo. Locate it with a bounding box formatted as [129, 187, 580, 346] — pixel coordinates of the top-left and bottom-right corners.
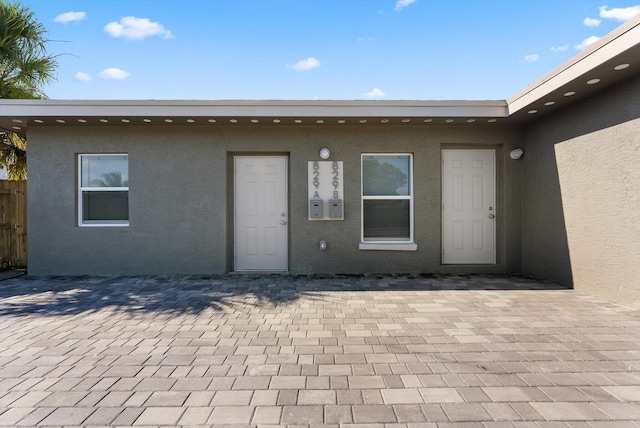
[0, 100, 507, 118]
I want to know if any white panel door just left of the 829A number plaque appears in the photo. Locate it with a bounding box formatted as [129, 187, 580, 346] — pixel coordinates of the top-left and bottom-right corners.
[234, 156, 289, 271]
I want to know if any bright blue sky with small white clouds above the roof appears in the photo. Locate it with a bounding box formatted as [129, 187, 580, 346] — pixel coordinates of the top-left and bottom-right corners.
[22, 0, 640, 100]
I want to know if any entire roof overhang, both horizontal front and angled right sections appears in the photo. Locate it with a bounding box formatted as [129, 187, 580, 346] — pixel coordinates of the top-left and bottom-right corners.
[0, 16, 640, 134]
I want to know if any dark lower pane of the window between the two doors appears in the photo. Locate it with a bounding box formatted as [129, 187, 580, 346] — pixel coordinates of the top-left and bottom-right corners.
[362, 199, 410, 240]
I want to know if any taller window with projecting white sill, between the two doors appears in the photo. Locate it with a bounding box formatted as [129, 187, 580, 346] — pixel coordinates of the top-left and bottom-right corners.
[360, 154, 416, 250]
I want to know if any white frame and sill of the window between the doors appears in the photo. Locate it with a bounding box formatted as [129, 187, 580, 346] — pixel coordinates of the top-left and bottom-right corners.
[359, 153, 418, 251]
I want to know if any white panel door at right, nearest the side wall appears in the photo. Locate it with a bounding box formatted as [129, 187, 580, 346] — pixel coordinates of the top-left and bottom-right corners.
[442, 149, 496, 264]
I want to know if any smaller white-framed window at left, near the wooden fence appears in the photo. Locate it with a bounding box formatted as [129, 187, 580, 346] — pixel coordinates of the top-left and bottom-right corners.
[78, 154, 129, 226]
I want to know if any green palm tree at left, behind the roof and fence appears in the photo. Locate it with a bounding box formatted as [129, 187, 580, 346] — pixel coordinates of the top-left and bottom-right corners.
[0, 0, 58, 180]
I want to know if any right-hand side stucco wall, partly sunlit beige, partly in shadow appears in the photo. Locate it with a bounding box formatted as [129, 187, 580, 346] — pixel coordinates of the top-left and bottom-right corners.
[522, 77, 640, 306]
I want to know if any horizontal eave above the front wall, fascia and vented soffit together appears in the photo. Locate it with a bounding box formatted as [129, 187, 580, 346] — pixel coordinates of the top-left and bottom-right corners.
[0, 100, 508, 132]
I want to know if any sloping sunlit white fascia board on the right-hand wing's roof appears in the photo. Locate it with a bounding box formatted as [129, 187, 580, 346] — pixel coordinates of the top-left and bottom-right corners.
[507, 15, 640, 115]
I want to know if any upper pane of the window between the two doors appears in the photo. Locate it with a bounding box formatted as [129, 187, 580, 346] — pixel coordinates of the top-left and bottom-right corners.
[362, 155, 411, 196]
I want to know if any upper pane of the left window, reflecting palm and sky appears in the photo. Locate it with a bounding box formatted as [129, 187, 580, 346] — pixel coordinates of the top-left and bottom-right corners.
[81, 155, 129, 187]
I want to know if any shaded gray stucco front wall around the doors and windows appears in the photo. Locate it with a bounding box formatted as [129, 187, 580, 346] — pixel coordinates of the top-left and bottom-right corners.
[28, 125, 521, 275]
